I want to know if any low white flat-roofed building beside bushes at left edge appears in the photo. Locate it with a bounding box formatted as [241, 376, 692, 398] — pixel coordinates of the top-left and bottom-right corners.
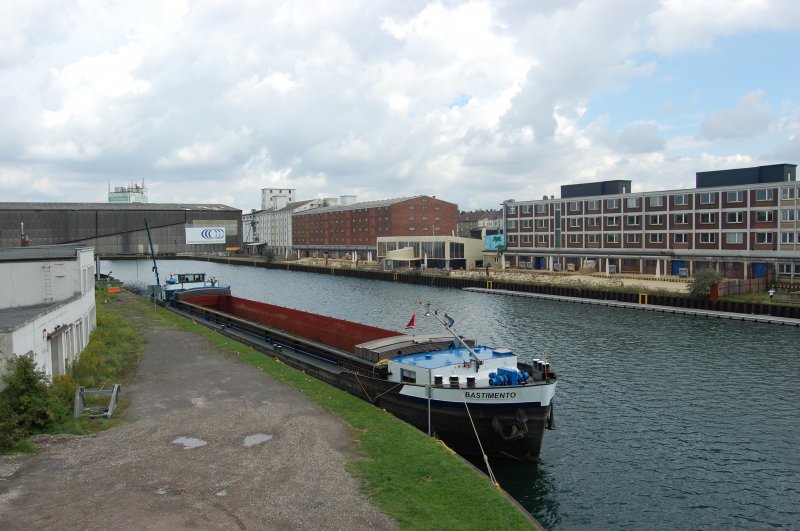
[0, 245, 97, 382]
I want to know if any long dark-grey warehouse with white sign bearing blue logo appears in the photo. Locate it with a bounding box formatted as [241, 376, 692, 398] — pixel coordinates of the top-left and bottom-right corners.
[0, 202, 242, 256]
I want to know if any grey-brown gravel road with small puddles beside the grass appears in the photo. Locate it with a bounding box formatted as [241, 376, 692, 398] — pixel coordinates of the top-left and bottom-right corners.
[0, 303, 397, 530]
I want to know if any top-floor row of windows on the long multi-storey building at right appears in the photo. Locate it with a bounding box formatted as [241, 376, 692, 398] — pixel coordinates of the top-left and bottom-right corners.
[506, 187, 796, 214]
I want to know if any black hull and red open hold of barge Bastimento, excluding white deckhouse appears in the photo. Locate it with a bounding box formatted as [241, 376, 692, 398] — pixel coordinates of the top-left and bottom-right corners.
[175, 295, 555, 461]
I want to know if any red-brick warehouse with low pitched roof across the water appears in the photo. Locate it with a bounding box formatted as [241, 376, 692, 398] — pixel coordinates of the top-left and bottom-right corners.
[292, 195, 458, 259]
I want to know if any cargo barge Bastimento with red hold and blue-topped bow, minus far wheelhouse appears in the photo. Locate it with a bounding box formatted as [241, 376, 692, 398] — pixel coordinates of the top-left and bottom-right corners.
[170, 289, 557, 461]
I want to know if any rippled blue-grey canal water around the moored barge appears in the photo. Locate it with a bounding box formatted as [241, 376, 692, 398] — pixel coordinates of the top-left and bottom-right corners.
[106, 261, 800, 530]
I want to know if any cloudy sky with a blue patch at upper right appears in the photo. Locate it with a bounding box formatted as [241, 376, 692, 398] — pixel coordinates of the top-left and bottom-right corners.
[0, 0, 800, 211]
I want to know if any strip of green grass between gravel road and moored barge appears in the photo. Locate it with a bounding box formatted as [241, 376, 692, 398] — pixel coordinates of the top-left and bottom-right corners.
[81, 297, 534, 529]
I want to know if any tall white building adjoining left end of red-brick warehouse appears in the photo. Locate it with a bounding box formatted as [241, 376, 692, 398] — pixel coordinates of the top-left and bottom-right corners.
[242, 188, 340, 258]
